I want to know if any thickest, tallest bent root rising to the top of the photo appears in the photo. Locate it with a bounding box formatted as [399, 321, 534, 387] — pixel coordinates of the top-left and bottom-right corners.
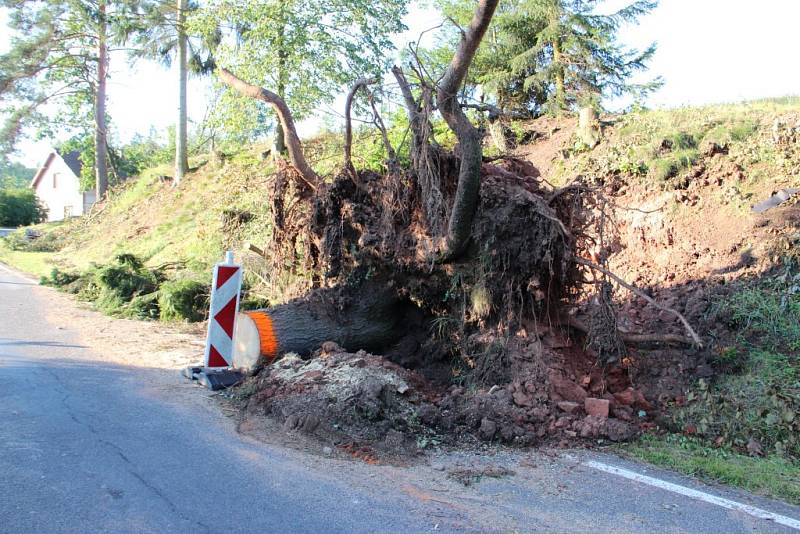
[436, 0, 498, 261]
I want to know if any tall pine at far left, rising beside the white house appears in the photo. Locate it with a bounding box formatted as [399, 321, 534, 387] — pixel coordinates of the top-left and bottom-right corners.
[0, 0, 136, 198]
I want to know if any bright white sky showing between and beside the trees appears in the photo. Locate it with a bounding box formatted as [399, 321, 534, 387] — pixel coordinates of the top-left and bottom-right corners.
[0, 0, 800, 166]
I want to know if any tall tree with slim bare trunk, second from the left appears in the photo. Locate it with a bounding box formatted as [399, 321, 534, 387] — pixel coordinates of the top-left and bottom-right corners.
[132, 0, 219, 185]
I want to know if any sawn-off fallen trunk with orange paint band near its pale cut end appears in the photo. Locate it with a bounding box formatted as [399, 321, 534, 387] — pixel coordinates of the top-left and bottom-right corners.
[234, 287, 408, 369]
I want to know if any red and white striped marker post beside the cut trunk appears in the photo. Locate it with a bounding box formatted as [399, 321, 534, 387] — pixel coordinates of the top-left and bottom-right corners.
[204, 250, 242, 370]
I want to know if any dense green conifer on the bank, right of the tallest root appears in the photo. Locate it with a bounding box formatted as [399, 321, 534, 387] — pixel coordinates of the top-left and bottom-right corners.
[439, 0, 660, 113]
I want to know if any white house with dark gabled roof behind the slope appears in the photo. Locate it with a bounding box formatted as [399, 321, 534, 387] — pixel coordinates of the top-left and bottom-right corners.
[31, 150, 95, 221]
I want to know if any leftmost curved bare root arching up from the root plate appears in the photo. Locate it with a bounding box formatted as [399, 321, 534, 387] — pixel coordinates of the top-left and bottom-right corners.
[217, 67, 320, 189]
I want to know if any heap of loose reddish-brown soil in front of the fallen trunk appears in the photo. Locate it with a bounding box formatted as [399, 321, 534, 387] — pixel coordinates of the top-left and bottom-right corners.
[241, 331, 651, 461]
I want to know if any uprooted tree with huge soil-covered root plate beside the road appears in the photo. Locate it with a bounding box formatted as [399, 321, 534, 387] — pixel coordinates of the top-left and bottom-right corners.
[219, 0, 699, 380]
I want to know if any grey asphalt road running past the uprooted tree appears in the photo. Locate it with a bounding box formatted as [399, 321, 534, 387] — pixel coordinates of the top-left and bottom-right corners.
[0, 266, 800, 533]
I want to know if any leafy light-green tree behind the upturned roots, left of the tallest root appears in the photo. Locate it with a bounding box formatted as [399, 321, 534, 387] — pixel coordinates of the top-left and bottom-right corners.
[190, 0, 407, 159]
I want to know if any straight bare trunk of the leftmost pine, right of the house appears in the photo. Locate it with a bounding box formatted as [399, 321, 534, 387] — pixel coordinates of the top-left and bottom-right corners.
[94, 0, 108, 201]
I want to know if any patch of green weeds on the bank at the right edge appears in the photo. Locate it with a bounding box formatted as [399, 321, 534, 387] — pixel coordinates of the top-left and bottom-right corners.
[672, 277, 800, 459]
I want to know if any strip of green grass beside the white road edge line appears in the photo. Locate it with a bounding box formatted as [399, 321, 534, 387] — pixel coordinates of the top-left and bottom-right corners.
[620, 434, 800, 504]
